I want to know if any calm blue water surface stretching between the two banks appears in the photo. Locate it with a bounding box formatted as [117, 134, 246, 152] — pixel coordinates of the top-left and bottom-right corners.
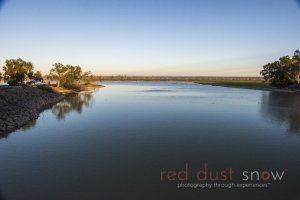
[0, 82, 300, 200]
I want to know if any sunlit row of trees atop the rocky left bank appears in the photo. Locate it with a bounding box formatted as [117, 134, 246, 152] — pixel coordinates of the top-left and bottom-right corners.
[0, 58, 93, 87]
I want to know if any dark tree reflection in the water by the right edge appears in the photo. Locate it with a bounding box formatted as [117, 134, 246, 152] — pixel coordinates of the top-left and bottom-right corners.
[260, 92, 300, 135]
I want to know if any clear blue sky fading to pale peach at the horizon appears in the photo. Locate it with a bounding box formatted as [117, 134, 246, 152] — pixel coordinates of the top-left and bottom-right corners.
[0, 0, 300, 76]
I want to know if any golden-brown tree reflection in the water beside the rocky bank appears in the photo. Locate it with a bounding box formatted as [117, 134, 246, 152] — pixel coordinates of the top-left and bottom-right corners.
[52, 92, 93, 120]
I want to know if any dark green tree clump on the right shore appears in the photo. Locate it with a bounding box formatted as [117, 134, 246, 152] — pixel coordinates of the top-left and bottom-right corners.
[260, 49, 300, 87]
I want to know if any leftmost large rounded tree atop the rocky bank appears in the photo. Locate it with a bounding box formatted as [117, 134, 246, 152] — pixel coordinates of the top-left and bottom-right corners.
[3, 58, 34, 85]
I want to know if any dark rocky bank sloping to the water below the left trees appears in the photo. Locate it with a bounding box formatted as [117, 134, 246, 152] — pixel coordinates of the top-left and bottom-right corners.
[0, 86, 65, 134]
